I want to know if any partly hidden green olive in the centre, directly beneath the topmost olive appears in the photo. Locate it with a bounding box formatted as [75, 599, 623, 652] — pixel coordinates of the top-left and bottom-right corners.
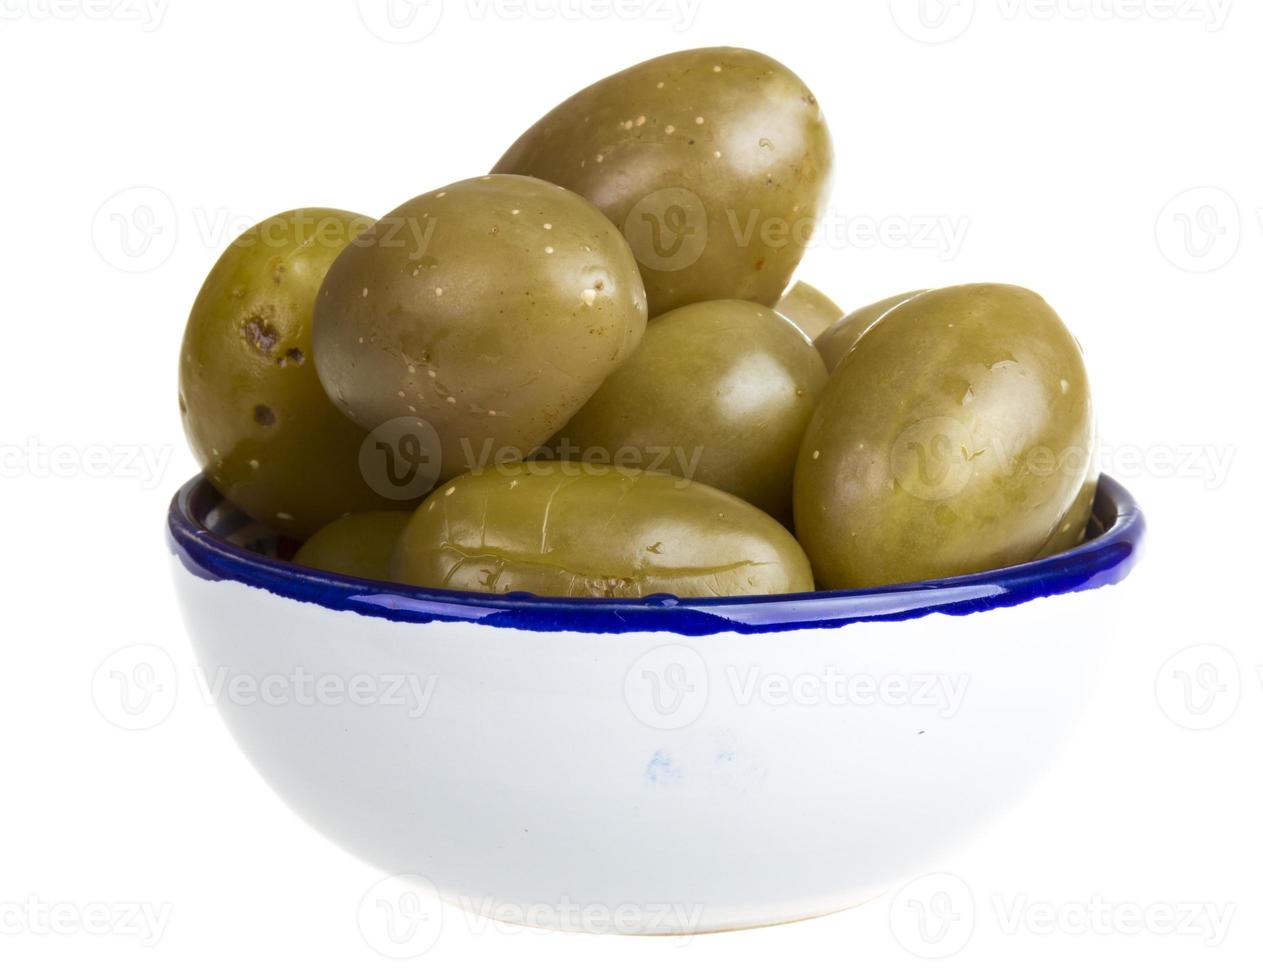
[552, 299, 827, 522]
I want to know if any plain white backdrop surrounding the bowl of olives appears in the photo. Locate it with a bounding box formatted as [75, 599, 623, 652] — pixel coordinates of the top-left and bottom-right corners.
[0, 0, 1263, 979]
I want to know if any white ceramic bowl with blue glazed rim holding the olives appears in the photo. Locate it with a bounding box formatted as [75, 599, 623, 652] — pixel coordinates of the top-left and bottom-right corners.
[168, 479, 1143, 933]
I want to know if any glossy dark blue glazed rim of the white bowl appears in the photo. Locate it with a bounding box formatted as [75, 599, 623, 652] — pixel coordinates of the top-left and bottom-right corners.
[167, 476, 1144, 636]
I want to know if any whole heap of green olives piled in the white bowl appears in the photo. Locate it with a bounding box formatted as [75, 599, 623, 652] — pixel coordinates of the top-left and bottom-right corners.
[179, 48, 1096, 597]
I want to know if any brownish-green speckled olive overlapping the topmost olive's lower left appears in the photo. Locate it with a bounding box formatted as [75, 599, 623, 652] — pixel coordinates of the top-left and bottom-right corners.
[314, 176, 645, 479]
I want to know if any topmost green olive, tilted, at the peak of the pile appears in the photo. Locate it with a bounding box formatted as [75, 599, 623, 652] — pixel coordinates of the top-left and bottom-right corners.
[493, 48, 834, 316]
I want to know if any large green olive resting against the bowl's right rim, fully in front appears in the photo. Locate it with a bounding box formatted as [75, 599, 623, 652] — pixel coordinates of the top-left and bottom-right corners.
[794, 284, 1094, 589]
